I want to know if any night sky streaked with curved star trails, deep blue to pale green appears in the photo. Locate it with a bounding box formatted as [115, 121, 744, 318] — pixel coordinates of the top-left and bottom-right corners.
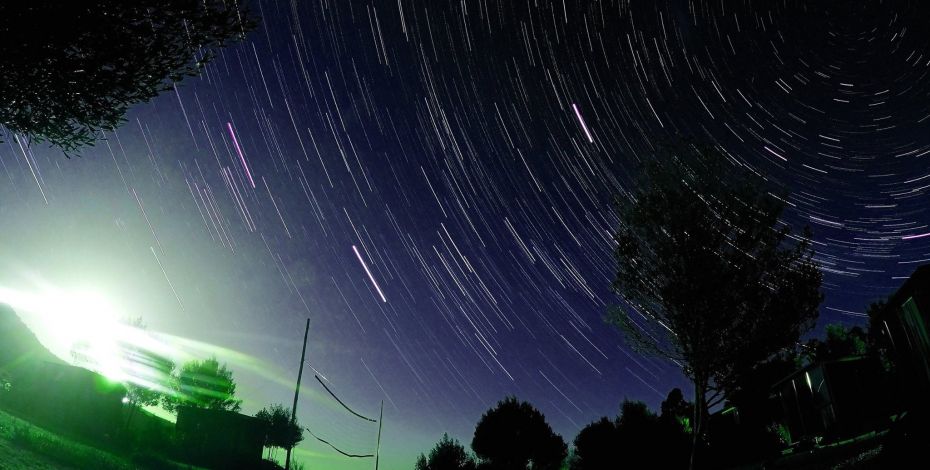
[0, 0, 930, 469]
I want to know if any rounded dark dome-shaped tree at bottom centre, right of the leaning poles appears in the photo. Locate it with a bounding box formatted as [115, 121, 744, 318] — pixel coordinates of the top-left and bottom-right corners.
[471, 397, 568, 470]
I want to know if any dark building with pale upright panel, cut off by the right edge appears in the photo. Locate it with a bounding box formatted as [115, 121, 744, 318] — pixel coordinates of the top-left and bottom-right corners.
[872, 265, 930, 408]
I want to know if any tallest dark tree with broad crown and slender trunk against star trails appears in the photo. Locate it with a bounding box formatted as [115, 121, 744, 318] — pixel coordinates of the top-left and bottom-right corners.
[608, 144, 823, 465]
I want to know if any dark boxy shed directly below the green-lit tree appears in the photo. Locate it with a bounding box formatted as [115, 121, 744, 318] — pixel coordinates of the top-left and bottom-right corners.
[175, 407, 266, 469]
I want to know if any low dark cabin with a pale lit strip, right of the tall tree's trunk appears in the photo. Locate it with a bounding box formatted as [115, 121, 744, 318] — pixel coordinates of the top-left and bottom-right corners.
[770, 356, 888, 443]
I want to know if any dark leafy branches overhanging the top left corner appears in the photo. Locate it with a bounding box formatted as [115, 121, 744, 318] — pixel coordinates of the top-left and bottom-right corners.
[0, 0, 256, 152]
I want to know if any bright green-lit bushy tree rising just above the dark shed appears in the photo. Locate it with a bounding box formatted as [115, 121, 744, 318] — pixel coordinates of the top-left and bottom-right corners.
[162, 357, 242, 413]
